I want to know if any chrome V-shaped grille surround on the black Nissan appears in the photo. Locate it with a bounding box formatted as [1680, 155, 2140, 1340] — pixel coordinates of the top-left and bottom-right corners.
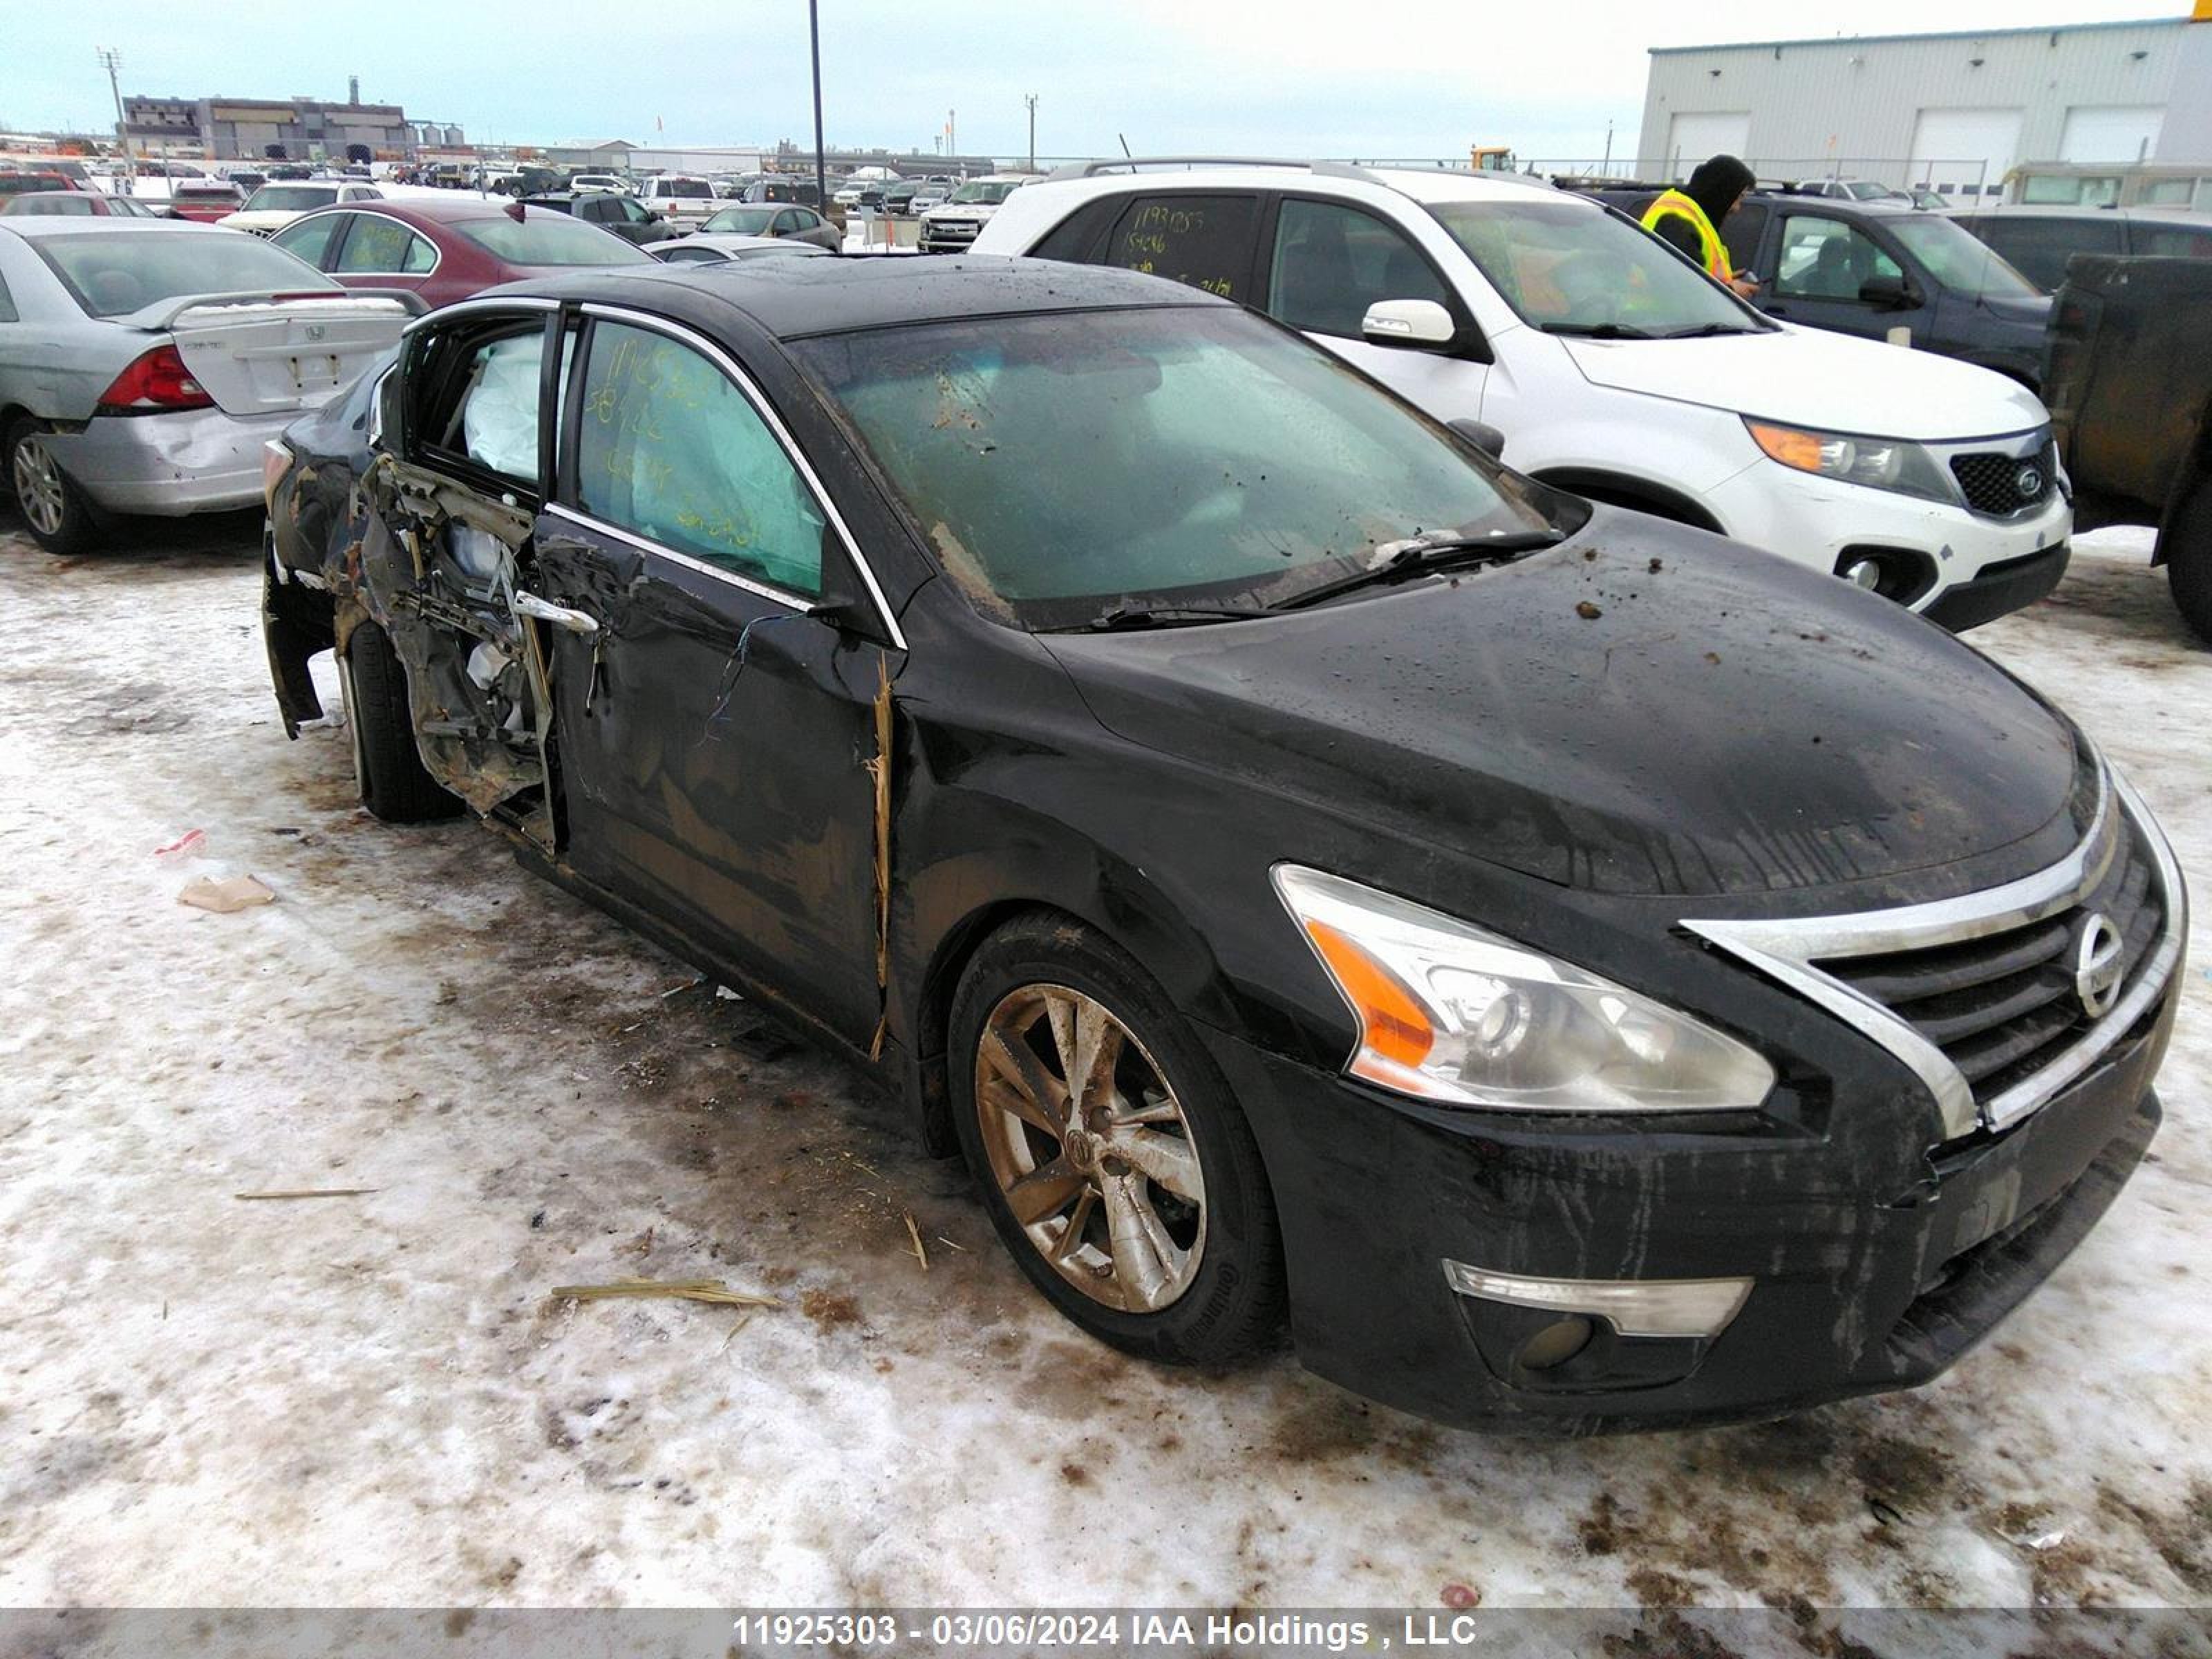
[1681, 759, 2188, 1139]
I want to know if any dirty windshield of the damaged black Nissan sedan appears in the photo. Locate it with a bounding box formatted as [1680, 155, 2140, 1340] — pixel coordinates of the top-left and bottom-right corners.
[794, 306, 1546, 628]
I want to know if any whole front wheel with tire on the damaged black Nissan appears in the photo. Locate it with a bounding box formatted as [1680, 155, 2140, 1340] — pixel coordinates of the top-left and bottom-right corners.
[949, 914, 1283, 1365]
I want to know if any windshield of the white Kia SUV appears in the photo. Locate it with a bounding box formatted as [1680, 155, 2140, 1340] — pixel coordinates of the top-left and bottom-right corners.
[1429, 199, 1770, 339]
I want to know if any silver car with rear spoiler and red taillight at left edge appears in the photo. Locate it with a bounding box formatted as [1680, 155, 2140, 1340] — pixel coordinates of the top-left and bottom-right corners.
[0, 217, 413, 553]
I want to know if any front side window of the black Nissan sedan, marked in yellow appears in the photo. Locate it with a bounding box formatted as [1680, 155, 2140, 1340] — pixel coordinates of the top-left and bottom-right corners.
[575, 323, 823, 597]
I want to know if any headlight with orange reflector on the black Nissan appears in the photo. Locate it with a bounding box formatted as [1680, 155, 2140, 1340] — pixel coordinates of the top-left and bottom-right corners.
[1274, 865, 1774, 1113]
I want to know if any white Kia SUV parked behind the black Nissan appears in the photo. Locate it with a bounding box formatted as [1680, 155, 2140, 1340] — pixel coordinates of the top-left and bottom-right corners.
[973, 159, 2072, 628]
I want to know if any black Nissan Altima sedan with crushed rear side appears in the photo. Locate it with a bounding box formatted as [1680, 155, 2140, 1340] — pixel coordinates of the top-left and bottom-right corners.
[263, 259, 2183, 1431]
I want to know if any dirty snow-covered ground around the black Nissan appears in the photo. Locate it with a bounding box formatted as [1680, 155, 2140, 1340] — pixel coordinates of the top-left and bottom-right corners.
[0, 520, 2212, 1608]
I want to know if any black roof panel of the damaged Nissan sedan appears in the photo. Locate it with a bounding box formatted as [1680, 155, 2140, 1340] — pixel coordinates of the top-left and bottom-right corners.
[487, 254, 1230, 341]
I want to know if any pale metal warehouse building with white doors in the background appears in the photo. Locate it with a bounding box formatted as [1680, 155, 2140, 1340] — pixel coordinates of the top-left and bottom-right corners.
[1637, 0, 2212, 197]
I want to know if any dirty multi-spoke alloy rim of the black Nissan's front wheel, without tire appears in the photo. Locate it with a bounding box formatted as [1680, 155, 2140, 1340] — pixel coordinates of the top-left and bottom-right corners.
[975, 984, 1206, 1314]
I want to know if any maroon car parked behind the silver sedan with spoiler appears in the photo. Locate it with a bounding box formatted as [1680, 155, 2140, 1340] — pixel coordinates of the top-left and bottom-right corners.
[270, 195, 655, 306]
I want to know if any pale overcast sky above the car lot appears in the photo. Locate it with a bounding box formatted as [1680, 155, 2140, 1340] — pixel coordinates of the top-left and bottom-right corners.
[0, 0, 2188, 159]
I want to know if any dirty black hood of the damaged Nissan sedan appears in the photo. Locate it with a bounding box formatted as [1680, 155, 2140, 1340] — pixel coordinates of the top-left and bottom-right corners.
[1047, 526, 2075, 894]
